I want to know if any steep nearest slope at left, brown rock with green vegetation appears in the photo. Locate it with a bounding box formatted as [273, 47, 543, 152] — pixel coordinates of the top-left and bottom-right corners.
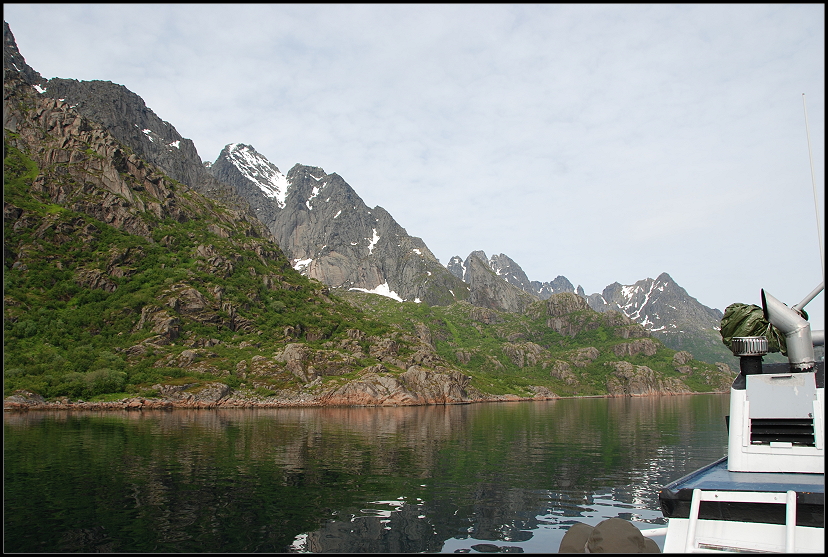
[3, 22, 472, 407]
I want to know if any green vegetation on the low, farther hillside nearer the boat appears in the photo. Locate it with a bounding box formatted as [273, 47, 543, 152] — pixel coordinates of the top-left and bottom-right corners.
[342, 292, 729, 396]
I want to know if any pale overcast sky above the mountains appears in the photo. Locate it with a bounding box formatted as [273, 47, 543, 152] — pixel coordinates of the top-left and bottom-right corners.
[3, 4, 825, 329]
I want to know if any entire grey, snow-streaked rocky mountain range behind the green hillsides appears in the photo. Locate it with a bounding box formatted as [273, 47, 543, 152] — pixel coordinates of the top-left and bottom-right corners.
[4, 20, 734, 364]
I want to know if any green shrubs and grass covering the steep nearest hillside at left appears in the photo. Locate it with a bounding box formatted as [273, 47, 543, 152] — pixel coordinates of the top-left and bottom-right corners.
[3, 142, 387, 399]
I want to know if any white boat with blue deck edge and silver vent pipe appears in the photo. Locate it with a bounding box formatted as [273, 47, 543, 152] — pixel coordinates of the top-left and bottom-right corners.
[642, 281, 825, 553]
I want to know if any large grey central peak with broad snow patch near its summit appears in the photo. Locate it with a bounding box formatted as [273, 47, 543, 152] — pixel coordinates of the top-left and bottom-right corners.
[209, 139, 468, 305]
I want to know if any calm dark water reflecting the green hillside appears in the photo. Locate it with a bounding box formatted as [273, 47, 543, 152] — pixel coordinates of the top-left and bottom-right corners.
[3, 395, 729, 553]
